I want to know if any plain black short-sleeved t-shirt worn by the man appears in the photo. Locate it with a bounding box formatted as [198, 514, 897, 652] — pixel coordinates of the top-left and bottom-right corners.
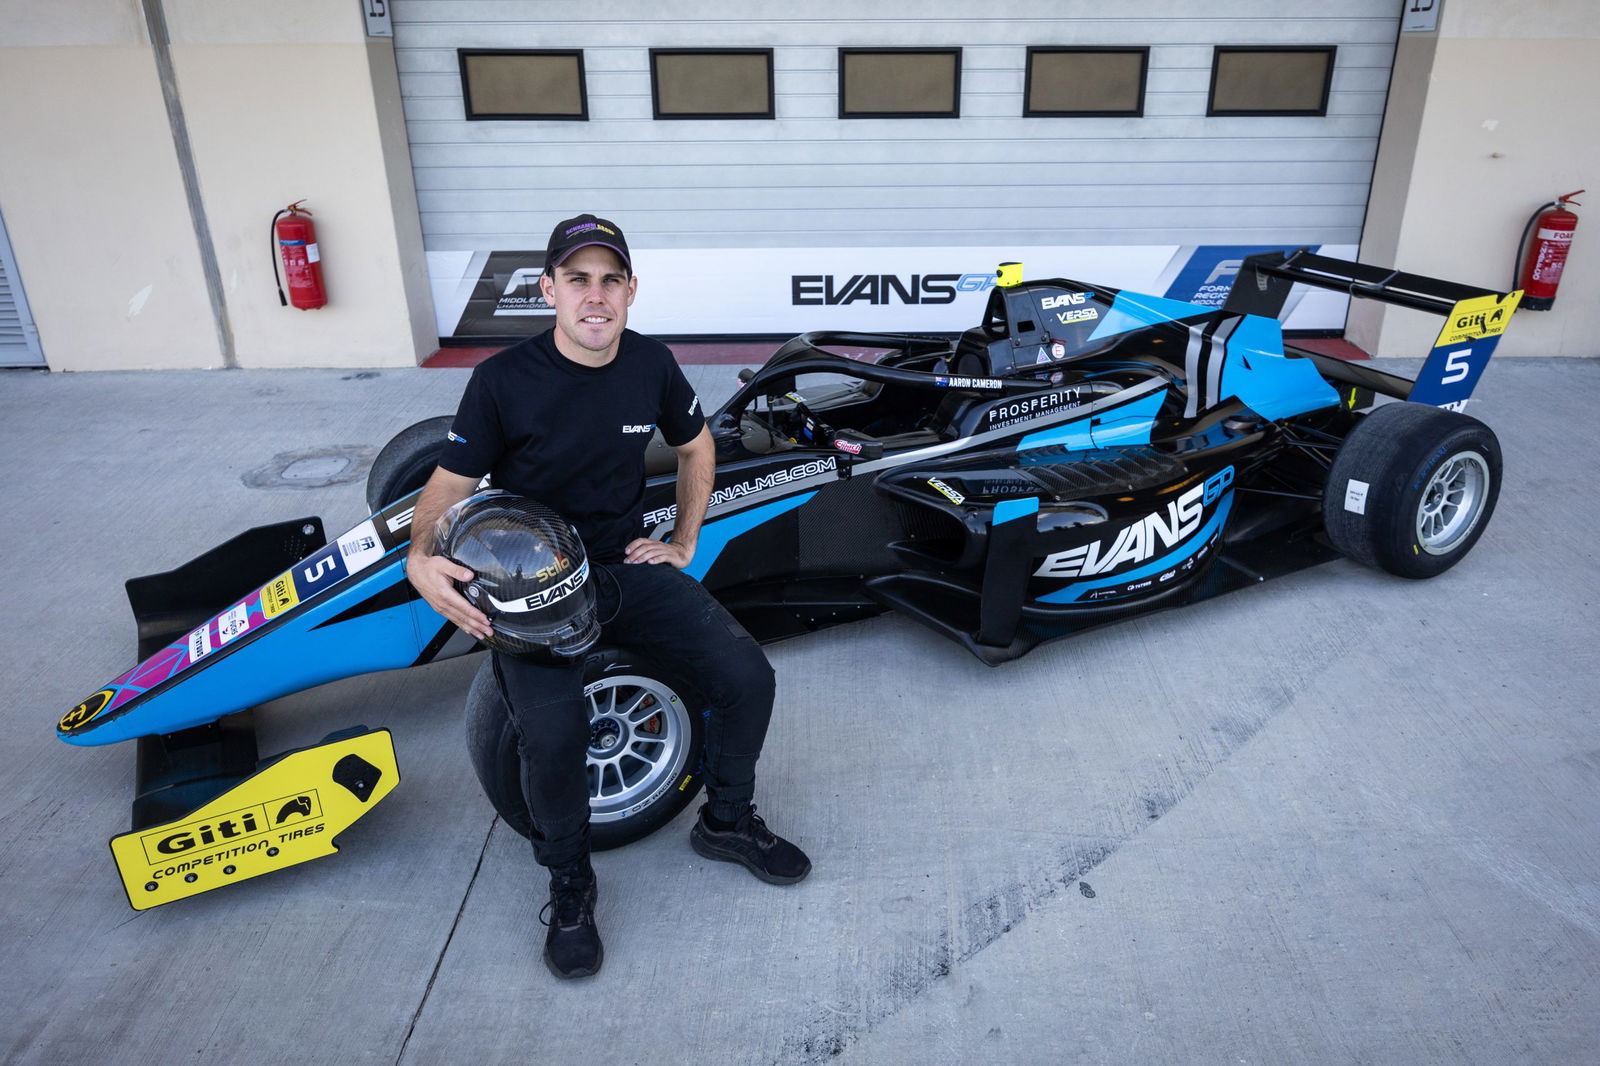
[438, 330, 706, 562]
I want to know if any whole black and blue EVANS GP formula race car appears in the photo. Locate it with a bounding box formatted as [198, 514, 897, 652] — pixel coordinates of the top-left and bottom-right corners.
[58, 250, 1520, 909]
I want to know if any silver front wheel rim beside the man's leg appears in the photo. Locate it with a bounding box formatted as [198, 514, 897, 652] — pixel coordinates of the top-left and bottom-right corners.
[584, 674, 691, 821]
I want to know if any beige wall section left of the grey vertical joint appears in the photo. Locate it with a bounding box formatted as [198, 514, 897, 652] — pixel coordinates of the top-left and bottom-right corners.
[0, 0, 222, 370]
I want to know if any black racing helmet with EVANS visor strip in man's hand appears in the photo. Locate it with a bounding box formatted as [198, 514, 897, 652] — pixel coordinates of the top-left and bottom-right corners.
[434, 490, 600, 663]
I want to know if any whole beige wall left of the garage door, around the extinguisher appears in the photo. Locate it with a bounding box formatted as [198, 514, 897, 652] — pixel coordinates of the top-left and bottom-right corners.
[0, 0, 435, 370]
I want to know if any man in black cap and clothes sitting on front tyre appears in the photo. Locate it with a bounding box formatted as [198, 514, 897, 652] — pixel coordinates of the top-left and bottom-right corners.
[406, 214, 811, 976]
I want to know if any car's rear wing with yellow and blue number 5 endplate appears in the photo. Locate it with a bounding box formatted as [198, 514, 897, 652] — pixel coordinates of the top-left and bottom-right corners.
[1222, 248, 1522, 411]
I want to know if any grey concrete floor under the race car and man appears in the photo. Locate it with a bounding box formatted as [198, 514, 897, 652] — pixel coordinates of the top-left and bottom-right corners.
[0, 360, 1600, 1066]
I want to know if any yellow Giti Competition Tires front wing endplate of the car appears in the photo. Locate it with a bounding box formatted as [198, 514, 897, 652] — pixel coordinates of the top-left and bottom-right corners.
[110, 730, 400, 911]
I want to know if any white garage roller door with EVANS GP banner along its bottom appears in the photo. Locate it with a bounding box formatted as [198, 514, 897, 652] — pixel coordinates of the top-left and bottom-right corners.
[394, 0, 1400, 336]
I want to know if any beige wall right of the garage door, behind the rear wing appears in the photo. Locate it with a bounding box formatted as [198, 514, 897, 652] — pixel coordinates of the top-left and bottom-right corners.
[1347, 0, 1600, 355]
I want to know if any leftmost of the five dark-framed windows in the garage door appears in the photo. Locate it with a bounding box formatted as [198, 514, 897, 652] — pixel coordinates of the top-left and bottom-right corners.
[456, 48, 589, 122]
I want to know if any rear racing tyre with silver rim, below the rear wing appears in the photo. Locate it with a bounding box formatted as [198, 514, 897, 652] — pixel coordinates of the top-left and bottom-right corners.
[1322, 403, 1501, 578]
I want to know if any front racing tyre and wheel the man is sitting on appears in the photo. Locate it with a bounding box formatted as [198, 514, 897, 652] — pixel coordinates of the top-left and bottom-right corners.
[467, 648, 704, 852]
